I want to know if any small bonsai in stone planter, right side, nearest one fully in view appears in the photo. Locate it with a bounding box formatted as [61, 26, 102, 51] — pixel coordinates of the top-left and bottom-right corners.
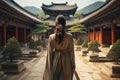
[88, 40, 101, 61]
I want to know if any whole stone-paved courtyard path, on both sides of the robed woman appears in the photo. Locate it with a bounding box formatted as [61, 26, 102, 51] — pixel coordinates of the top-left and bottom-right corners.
[8, 48, 120, 80]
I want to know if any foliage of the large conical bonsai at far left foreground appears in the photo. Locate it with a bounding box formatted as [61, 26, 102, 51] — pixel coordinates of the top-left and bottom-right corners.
[3, 37, 22, 62]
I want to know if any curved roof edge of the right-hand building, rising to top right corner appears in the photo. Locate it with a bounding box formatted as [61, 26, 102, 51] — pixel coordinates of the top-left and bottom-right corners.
[79, 0, 120, 23]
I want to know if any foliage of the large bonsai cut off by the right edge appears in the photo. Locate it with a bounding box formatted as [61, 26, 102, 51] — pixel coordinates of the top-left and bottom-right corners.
[107, 39, 120, 64]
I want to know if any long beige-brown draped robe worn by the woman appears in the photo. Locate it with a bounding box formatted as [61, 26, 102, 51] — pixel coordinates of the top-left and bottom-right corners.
[43, 33, 75, 80]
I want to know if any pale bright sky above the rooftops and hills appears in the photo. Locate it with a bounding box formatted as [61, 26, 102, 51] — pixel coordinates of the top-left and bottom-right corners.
[14, 0, 105, 10]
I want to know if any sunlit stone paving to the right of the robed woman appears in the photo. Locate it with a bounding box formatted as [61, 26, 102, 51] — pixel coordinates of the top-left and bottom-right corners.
[75, 51, 120, 80]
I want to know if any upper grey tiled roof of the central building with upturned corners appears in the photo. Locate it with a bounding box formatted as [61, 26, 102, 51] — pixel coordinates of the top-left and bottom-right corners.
[41, 2, 77, 19]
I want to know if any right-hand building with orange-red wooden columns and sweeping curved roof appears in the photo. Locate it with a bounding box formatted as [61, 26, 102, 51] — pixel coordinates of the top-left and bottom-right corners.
[79, 0, 120, 45]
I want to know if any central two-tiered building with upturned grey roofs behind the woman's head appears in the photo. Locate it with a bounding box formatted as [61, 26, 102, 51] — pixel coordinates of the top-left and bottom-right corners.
[41, 2, 78, 36]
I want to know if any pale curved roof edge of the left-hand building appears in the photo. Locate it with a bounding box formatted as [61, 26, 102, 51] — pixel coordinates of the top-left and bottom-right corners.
[2, 0, 42, 23]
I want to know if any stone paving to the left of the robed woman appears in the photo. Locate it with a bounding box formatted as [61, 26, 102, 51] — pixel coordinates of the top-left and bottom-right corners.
[8, 51, 46, 80]
